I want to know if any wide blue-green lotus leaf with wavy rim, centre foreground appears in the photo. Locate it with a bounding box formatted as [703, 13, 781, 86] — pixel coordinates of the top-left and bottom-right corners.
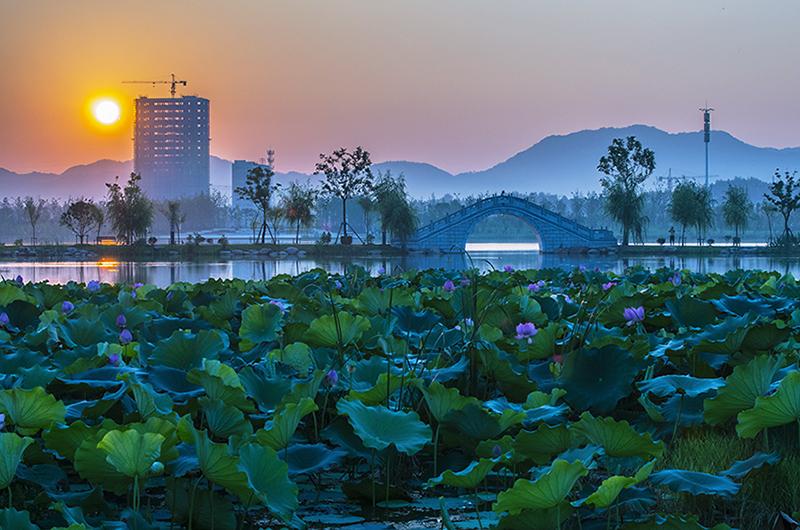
[336, 399, 431, 455]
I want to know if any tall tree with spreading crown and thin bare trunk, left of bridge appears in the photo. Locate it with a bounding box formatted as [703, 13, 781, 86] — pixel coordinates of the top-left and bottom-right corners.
[314, 146, 372, 244]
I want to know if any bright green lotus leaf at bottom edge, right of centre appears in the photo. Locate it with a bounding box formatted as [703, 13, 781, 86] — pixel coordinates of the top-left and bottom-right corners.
[492, 460, 589, 515]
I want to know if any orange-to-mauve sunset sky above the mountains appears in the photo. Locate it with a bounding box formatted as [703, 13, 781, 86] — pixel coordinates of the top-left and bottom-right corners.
[0, 0, 800, 172]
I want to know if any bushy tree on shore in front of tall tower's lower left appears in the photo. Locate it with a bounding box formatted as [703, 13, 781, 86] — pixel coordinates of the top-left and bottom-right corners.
[106, 173, 154, 245]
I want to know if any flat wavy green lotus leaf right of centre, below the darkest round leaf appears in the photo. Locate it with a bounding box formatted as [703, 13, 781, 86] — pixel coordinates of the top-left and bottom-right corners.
[570, 412, 664, 460]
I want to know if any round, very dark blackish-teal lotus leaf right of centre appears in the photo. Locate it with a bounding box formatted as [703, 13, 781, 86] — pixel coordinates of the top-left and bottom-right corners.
[559, 345, 640, 414]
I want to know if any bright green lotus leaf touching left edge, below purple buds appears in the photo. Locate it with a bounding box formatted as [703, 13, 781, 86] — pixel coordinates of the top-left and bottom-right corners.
[0, 387, 67, 434]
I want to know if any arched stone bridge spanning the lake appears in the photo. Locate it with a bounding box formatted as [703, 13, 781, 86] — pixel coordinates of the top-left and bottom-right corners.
[406, 195, 617, 253]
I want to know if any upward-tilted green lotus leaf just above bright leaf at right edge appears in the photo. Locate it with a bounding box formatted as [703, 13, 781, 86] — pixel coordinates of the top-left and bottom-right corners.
[703, 355, 783, 425]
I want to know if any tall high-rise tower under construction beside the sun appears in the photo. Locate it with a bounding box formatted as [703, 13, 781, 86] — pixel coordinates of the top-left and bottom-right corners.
[133, 96, 211, 199]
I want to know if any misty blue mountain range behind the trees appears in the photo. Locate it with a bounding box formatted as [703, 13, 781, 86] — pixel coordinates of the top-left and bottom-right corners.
[0, 125, 800, 198]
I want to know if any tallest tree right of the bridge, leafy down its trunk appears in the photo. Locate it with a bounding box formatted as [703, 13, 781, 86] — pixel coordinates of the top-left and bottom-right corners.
[597, 136, 656, 246]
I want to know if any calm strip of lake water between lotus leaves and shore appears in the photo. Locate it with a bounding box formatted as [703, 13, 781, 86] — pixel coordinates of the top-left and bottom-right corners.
[0, 243, 800, 286]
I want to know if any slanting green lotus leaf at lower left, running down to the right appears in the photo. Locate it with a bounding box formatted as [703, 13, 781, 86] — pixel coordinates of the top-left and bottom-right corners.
[178, 416, 250, 502]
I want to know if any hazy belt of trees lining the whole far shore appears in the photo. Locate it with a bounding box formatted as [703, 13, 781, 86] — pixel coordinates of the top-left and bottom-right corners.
[0, 137, 800, 246]
